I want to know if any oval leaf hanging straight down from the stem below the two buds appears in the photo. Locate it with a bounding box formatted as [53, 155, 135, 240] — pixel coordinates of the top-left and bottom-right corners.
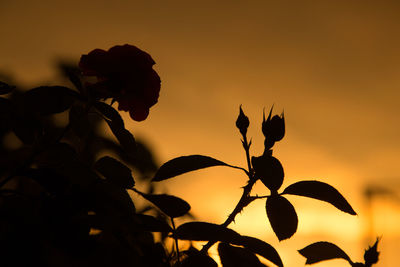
[266, 195, 298, 241]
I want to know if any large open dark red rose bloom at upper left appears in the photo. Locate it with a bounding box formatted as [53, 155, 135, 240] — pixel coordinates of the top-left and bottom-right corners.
[79, 44, 161, 121]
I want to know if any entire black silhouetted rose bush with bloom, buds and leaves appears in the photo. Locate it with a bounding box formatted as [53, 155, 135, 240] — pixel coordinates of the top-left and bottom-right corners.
[0, 45, 379, 267]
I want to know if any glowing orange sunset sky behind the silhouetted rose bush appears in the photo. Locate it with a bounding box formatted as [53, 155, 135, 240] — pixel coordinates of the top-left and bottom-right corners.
[0, 0, 400, 267]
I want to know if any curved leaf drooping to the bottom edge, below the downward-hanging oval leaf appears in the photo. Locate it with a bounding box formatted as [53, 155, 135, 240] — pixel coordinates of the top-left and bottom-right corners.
[238, 236, 283, 267]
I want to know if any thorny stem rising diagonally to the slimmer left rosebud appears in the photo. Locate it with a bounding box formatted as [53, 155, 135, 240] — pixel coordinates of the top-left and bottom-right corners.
[201, 134, 256, 253]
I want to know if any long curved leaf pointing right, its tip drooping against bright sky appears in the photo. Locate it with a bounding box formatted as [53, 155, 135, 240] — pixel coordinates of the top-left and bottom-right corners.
[282, 181, 357, 215]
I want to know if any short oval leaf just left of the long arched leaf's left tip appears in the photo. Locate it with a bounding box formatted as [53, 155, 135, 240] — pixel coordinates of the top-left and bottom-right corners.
[94, 156, 135, 189]
